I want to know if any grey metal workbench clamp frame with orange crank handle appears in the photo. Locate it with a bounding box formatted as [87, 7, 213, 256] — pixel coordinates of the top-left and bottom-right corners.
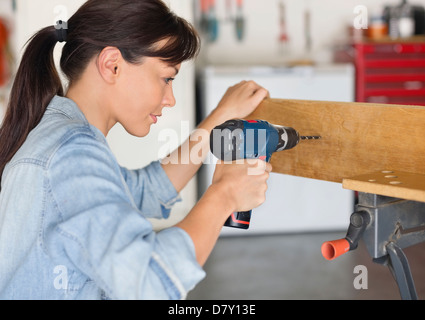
[322, 192, 425, 300]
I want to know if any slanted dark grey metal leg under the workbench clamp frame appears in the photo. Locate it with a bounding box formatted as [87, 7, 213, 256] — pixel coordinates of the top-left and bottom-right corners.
[386, 242, 418, 300]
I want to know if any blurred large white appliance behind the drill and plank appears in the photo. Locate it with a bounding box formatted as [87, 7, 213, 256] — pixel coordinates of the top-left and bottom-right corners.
[199, 65, 354, 235]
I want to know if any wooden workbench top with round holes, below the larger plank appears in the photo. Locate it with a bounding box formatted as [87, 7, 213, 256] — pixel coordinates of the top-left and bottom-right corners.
[342, 170, 425, 202]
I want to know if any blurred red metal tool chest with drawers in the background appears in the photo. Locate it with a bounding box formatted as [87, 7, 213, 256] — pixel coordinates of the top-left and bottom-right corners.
[354, 42, 425, 105]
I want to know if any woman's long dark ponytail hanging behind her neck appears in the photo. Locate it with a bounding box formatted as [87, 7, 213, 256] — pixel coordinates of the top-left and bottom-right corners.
[0, 26, 63, 181]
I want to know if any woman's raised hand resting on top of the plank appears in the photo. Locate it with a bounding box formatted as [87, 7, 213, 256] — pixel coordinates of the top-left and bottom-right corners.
[208, 81, 269, 125]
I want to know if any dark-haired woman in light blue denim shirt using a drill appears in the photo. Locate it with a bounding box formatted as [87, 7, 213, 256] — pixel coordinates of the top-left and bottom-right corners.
[0, 0, 271, 299]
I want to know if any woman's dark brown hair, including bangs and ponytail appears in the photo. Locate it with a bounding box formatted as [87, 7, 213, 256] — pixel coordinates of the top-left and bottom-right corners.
[0, 0, 200, 186]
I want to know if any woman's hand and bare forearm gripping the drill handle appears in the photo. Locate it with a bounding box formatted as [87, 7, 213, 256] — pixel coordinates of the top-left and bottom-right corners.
[176, 159, 272, 266]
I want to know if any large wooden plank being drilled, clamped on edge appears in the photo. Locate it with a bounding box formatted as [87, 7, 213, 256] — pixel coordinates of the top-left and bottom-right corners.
[247, 99, 425, 183]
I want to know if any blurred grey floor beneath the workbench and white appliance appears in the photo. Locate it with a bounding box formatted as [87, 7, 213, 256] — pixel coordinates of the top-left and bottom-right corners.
[188, 232, 425, 300]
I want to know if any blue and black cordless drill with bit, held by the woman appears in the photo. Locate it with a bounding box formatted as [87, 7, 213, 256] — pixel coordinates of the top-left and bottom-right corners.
[210, 119, 320, 229]
